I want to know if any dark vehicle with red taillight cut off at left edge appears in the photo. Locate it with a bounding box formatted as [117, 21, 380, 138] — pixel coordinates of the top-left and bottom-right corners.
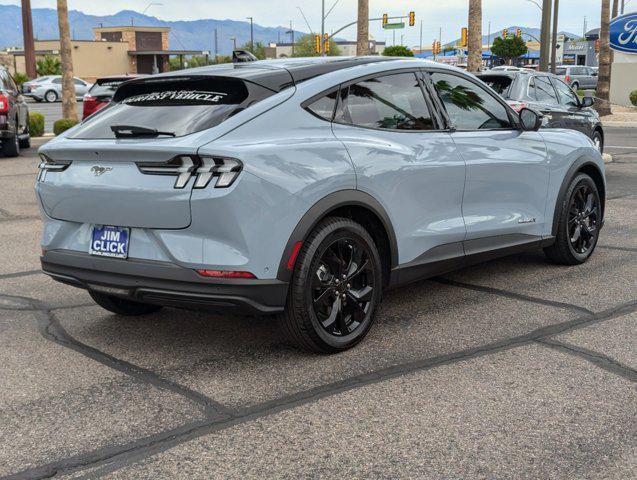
[0, 66, 31, 157]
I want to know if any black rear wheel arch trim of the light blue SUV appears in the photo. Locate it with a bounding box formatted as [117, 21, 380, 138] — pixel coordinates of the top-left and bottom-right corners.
[277, 190, 398, 284]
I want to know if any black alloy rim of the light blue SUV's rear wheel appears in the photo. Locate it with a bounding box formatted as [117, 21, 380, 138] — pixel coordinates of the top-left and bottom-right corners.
[311, 237, 375, 337]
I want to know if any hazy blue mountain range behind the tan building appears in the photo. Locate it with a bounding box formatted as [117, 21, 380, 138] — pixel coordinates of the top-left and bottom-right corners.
[0, 5, 306, 55]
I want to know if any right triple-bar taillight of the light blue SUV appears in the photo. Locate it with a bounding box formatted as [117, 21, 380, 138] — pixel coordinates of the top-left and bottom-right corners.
[137, 155, 243, 188]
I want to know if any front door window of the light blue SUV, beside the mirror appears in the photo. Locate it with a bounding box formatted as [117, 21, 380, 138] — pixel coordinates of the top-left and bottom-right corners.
[431, 72, 511, 130]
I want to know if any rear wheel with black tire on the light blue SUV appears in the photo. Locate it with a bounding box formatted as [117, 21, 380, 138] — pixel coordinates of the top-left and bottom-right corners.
[279, 217, 382, 353]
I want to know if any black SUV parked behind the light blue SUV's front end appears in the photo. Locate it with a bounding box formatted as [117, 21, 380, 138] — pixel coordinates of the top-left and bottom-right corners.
[478, 70, 604, 152]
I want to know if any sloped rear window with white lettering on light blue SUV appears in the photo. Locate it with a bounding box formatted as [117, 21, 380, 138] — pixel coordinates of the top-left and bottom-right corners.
[71, 76, 276, 139]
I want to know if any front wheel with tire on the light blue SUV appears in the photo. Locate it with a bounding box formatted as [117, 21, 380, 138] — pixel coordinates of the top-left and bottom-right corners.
[544, 173, 602, 265]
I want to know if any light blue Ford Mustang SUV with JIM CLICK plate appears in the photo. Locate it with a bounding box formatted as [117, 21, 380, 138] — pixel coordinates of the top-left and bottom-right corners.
[36, 57, 606, 352]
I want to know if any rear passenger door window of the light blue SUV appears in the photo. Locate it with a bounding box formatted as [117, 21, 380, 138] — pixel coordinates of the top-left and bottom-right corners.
[339, 73, 435, 130]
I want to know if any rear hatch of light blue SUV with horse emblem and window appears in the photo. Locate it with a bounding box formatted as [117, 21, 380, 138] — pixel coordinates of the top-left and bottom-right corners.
[37, 72, 289, 229]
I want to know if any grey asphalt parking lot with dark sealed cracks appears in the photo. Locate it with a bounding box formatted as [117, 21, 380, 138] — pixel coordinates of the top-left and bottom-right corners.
[0, 129, 637, 479]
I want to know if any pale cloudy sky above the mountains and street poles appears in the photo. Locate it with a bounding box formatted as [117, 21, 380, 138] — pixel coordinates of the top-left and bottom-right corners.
[0, 0, 608, 47]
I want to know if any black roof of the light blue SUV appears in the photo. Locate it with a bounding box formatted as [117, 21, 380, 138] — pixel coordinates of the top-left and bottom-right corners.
[133, 56, 458, 92]
